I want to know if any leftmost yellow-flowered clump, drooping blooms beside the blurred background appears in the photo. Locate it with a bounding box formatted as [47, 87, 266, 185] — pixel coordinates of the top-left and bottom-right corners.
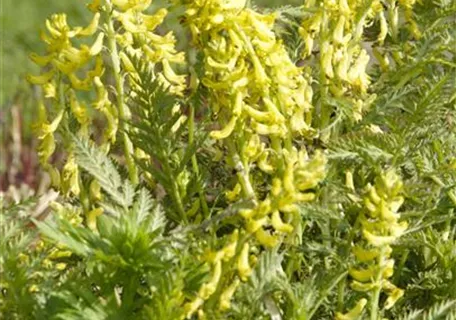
[27, 0, 185, 214]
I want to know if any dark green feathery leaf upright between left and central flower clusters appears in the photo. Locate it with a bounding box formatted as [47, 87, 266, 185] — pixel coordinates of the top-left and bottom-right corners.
[124, 52, 208, 221]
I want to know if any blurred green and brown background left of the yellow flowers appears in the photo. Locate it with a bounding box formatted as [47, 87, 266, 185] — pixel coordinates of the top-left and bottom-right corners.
[0, 0, 303, 190]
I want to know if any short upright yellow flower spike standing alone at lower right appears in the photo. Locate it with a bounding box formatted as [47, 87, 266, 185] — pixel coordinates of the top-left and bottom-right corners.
[338, 170, 407, 319]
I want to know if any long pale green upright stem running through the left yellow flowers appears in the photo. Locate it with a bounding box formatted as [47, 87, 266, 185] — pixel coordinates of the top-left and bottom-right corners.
[106, 0, 139, 185]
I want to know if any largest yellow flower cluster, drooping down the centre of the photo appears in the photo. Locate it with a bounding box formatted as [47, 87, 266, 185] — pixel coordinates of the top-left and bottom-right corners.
[181, 0, 326, 317]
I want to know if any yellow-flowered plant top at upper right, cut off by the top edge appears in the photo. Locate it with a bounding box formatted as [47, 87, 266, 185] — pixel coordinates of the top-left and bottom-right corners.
[299, 0, 420, 140]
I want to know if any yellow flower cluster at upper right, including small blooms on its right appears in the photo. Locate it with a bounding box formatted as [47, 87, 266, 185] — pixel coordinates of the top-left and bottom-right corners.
[299, 0, 419, 125]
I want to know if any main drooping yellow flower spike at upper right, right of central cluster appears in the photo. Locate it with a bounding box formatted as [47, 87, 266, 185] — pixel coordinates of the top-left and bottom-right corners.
[299, 0, 386, 125]
